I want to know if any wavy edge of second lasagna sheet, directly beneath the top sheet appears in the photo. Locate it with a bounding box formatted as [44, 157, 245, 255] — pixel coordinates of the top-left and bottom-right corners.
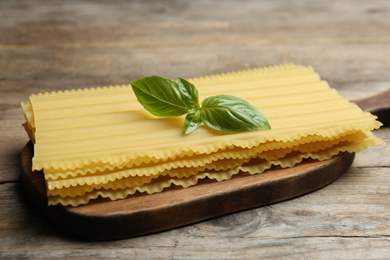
[40, 132, 372, 185]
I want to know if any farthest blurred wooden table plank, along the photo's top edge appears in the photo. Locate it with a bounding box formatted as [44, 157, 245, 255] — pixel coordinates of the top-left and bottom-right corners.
[0, 0, 389, 48]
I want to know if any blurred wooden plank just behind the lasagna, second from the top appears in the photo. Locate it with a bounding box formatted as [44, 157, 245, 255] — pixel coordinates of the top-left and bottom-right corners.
[0, 43, 390, 82]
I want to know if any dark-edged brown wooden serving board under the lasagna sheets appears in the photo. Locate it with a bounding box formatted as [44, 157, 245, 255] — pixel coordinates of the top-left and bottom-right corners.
[21, 91, 390, 240]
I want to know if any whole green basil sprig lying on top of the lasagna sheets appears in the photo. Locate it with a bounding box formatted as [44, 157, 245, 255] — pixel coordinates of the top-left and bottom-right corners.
[131, 76, 271, 135]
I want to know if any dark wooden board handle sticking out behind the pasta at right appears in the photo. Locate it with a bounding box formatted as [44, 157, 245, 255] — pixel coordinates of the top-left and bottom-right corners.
[352, 89, 390, 127]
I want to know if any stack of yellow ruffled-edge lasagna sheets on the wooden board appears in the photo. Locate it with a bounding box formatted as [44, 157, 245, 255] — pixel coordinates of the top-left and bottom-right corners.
[22, 64, 383, 206]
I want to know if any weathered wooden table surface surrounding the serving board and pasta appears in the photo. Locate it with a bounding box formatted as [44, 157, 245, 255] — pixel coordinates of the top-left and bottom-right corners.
[0, 0, 390, 259]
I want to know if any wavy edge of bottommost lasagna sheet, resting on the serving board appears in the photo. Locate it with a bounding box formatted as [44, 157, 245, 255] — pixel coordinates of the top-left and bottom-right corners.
[49, 131, 380, 206]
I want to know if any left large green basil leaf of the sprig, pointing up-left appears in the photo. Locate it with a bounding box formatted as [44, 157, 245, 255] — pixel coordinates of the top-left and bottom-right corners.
[131, 76, 188, 117]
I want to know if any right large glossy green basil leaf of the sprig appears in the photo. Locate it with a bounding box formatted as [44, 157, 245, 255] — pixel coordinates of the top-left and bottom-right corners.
[200, 95, 271, 133]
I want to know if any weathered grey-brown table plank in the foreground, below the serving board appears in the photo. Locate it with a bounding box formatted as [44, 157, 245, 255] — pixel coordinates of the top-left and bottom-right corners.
[0, 168, 390, 259]
